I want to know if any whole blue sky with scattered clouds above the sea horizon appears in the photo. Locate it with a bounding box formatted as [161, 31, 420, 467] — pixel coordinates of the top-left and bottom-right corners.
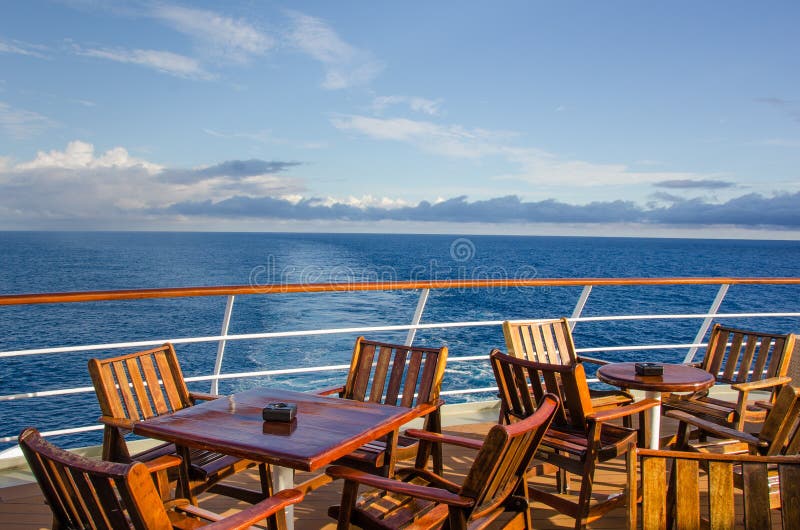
[0, 0, 800, 239]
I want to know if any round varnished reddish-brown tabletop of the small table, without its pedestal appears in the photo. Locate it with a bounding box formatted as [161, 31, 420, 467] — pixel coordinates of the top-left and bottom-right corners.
[597, 363, 714, 392]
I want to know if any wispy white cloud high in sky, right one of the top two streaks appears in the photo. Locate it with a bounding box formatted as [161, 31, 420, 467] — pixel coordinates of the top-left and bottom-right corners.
[287, 11, 383, 90]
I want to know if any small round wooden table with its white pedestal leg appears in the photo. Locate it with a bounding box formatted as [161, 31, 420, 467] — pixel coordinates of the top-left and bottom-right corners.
[597, 363, 715, 449]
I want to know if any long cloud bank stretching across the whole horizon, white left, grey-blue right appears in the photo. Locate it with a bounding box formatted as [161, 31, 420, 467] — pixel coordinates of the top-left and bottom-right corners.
[0, 142, 800, 230]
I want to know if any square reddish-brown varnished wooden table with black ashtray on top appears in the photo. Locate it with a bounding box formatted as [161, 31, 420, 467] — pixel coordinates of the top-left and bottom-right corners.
[133, 388, 420, 528]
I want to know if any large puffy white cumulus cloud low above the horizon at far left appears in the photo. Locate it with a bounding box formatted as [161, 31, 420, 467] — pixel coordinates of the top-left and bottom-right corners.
[0, 141, 305, 219]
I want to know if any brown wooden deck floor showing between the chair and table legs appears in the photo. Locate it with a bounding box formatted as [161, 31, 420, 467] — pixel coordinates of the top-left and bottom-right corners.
[0, 416, 780, 530]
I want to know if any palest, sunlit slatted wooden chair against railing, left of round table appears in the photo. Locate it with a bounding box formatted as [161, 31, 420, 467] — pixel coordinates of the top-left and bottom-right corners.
[503, 318, 633, 410]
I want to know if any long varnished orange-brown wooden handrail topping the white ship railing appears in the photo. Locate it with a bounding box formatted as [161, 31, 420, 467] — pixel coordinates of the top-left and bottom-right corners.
[0, 278, 800, 305]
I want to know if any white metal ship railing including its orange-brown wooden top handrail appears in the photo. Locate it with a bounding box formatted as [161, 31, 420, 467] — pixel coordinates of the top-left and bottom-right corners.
[0, 278, 800, 446]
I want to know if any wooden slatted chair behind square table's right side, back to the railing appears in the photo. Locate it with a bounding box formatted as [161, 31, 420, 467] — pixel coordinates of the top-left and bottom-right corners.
[318, 337, 447, 476]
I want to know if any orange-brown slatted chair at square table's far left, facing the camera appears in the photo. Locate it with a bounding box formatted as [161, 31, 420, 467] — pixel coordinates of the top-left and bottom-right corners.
[89, 344, 262, 503]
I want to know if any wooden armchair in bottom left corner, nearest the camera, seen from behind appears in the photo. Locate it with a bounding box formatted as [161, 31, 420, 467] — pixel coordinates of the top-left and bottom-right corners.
[19, 429, 303, 530]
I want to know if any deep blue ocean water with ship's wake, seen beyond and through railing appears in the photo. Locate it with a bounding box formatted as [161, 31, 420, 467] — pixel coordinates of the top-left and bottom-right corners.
[0, 232, 800, 449]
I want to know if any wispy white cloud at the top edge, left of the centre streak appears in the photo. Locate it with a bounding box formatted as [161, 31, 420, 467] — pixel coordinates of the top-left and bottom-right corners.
[153, 5, 275, 63]
